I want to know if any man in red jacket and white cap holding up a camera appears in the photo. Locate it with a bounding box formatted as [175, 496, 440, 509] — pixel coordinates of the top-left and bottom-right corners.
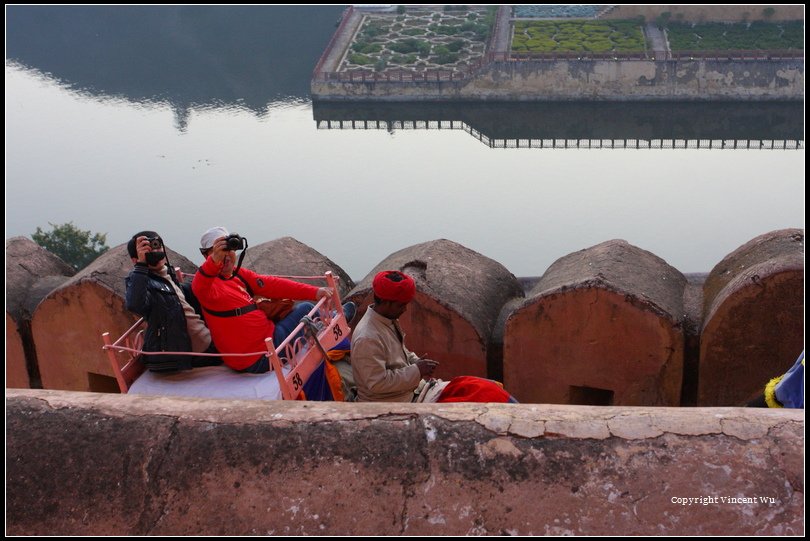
[191, 227, 349, 373]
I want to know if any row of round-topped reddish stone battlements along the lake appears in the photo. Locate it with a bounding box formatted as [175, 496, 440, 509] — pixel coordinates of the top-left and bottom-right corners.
[7, 229, 804, 406]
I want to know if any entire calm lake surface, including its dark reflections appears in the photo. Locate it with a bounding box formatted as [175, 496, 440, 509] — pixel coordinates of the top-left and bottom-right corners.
[5, 6, 805, 280]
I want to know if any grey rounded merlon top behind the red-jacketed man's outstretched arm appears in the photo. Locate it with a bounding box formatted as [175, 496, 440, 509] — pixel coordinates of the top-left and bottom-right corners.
[243, 237, 354, 296]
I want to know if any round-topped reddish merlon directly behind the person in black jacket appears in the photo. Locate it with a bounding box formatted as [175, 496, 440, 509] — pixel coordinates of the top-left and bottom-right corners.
[31, 244, 196, 392]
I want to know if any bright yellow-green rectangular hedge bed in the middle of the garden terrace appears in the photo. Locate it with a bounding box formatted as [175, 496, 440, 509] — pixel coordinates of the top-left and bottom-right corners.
[512, 20, 645, 53]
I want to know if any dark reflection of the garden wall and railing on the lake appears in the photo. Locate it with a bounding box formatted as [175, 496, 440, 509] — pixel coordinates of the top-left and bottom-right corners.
[312, 102, 804, 148]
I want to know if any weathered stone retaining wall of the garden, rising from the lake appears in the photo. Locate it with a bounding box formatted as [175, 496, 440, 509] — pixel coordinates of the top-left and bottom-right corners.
[312, 59, 804, 101]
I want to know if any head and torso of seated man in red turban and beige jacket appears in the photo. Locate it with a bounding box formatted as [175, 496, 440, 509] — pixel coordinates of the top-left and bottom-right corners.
[352, 270, 438, 402]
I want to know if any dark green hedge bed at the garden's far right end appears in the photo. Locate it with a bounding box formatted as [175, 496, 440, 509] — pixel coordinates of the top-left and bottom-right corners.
[666, 21, 804, 51]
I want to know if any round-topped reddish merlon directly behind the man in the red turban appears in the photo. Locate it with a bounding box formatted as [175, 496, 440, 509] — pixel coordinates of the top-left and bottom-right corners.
[349, 239, 523, 379]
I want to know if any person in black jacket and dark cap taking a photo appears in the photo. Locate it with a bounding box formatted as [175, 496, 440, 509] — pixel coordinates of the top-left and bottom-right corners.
[126, 231, 222, 372]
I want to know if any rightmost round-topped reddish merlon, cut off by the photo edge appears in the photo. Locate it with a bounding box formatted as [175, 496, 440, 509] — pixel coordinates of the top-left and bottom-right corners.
[698, 229, 804, 406]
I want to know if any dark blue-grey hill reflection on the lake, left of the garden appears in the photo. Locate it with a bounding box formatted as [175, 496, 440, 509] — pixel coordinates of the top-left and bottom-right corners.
[6, 6, 343, 129]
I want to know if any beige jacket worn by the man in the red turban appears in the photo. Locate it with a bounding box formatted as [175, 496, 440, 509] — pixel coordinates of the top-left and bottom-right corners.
[351, 305, 422, 402]
